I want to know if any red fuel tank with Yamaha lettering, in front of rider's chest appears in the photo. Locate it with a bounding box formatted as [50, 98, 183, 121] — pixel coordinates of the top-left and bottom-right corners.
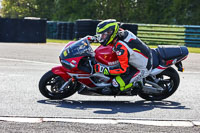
[95, 45, 119, 66]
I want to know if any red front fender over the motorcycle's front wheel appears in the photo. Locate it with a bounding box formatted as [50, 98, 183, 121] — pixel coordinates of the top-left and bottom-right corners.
[51, 66, 70, 81]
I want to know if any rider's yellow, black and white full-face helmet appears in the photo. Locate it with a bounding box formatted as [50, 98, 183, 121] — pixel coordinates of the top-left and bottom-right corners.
[96, 19, 119, 46]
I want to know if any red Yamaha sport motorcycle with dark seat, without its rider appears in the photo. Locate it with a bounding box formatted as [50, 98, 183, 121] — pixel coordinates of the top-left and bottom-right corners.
[39, 37, 189, 100]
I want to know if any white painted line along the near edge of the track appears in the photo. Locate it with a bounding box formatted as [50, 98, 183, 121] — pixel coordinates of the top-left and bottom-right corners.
[0, 117, 200, 127]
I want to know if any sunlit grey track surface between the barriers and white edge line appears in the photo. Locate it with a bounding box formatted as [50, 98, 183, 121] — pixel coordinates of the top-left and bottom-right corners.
[0, 43, 200, 132]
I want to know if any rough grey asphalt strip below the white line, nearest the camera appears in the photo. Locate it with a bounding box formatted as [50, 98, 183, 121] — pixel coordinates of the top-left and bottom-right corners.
[0, 122, 200, 133]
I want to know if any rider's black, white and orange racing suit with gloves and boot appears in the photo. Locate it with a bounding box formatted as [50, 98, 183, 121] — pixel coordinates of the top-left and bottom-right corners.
[94, 30, 152, 91]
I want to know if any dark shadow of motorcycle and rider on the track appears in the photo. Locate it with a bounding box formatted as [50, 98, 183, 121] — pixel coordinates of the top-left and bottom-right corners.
[38, 100, 189, 114]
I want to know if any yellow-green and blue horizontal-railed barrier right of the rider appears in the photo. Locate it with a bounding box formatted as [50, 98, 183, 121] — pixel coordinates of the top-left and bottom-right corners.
[137, 24, 200, 47]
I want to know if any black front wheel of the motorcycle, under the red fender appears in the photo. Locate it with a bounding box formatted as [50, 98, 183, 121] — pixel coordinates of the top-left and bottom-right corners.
[39, 71, 76, 99]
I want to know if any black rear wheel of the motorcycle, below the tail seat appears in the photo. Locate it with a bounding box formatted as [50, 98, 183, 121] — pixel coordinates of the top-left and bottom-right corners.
[139, 67, 180, 100]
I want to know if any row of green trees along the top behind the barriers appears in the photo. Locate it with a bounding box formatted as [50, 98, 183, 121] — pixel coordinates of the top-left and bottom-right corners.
[1, 0, 200, 25]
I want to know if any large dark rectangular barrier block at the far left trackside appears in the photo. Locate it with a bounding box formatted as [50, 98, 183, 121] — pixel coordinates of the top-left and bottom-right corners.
[0, 18, 46, 43]
